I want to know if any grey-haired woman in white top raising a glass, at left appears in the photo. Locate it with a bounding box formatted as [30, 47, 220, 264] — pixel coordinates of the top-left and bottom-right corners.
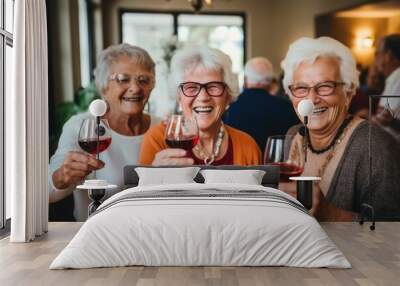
[49, 44, 160, 220]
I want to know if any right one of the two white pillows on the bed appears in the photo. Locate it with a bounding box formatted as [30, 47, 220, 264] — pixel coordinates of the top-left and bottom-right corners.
[200, 170, 265, 185]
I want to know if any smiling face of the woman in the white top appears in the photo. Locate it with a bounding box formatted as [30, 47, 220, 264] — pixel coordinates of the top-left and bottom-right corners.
[102, 55, 153, 116]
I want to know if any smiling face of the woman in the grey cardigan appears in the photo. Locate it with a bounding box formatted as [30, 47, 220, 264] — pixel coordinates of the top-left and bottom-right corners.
[291, 57, 351, 133]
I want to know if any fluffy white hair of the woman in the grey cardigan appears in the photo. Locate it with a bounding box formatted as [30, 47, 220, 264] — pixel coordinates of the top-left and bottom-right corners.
[281, 37, 359, 96]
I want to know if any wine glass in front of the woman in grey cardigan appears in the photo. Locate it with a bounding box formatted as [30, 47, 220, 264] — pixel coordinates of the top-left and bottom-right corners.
[264, 135, 304, 182]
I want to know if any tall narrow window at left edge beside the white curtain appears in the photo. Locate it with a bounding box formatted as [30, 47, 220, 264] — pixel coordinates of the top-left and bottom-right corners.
[0, 0, 14, 228]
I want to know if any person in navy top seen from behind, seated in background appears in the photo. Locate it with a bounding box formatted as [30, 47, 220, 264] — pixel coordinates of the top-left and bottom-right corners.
[224, 57, 299, 152]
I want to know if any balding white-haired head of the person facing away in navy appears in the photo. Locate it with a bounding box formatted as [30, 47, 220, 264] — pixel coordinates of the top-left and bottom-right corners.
[244, 57, 274, 85]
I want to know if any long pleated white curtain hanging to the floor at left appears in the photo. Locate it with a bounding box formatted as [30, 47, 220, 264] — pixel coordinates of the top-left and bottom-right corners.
[6, 0, 48, 242]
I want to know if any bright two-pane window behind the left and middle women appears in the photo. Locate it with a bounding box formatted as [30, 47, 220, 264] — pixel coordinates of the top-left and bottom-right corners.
[120, 10, 245, 117]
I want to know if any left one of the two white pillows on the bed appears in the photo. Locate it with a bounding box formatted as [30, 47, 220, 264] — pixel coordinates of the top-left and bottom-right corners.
[135, 167, 200, 186]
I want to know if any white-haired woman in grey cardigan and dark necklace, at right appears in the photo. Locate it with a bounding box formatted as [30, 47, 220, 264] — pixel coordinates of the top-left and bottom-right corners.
[282, 37, 400, 220]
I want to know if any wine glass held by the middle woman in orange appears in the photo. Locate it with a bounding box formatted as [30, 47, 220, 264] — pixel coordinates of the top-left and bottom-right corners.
[165, 114, 199, 151]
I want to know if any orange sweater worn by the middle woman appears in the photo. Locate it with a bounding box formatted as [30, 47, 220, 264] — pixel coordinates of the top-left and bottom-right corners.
[139, 123, 261, 166]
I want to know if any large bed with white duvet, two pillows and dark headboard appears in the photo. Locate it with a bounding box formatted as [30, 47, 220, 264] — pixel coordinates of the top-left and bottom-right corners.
[50, 166, 351, 269]
